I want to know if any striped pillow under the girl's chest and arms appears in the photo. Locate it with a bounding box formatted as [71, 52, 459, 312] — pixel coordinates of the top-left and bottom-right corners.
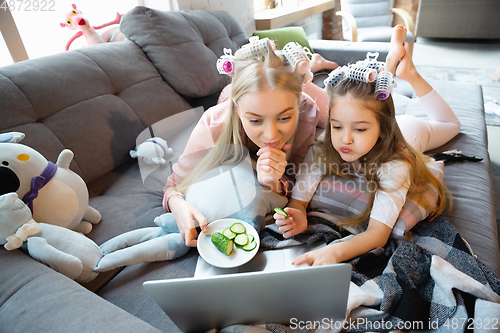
[309, 161, 444, 239]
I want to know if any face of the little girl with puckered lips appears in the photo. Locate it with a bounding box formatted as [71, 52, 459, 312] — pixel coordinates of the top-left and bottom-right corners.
[330, 94, 380, 162]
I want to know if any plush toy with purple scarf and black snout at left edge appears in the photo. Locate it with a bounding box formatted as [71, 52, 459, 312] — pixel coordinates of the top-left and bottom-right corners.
[0, 132, 101, 234]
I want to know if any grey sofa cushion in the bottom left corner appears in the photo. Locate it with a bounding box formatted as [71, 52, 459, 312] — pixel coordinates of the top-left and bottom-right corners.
[0, 249, 160, 333]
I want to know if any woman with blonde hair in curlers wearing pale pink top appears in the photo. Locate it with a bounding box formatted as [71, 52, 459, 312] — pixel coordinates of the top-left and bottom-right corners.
[163, 42, 328, 246]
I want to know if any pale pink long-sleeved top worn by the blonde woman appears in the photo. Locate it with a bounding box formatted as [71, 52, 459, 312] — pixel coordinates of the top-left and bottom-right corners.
[163, 93, 320, 212]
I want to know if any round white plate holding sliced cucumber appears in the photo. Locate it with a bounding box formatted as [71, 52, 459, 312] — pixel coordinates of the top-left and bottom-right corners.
[197, 219, 260, 268]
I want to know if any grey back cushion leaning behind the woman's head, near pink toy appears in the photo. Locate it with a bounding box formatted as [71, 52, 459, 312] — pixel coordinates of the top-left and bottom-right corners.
[120, 7, 248, 97]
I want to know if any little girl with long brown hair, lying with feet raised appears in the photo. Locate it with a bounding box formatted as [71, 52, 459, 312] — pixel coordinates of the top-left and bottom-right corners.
[274, 26, 460, 265]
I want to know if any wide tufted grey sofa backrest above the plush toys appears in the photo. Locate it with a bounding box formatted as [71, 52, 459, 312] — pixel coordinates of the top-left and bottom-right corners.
[0, 41, 191, 182]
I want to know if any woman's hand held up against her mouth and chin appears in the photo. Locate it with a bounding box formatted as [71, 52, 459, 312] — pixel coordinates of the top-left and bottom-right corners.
[257, 144, 292, 186]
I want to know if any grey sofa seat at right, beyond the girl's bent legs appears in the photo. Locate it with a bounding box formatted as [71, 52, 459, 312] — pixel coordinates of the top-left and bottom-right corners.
[406, 81, 500, 276]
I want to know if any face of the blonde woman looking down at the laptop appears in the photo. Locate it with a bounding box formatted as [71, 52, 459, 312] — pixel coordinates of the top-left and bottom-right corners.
[237, 89, 299, 149]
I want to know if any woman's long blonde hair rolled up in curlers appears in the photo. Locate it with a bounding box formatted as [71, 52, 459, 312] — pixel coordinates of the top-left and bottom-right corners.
[176, 45, 303, 193]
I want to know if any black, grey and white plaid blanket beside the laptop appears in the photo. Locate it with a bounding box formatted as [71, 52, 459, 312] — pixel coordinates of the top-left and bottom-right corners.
[223, 213, 500, 333]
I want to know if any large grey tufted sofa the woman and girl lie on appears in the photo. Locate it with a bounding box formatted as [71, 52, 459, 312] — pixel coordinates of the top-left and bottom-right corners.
[0, 7, 500, 332]
